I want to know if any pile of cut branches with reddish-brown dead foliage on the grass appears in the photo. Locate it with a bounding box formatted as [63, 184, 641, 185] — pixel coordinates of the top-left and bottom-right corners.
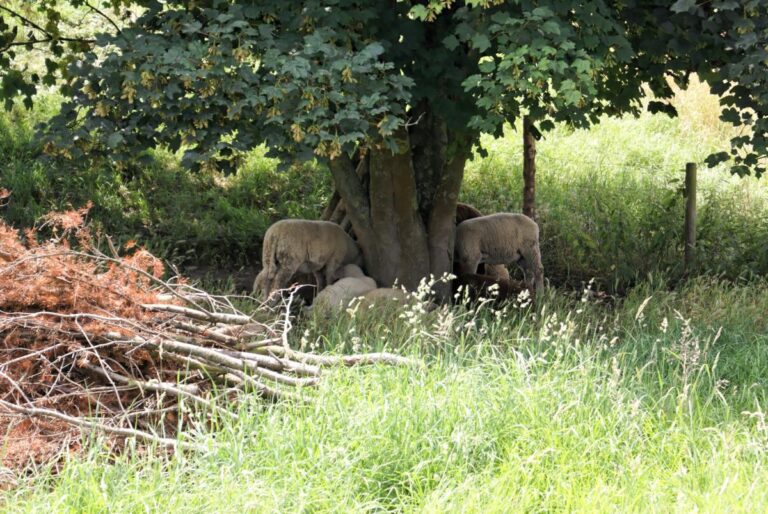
[0, 203, 410, 467]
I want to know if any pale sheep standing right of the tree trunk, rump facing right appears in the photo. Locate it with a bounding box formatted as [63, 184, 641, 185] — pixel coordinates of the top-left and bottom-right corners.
[456, 212, 544, 295]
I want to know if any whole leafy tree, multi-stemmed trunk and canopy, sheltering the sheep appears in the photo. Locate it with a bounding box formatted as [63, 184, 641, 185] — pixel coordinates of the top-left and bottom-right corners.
[0, 0, 768, 295]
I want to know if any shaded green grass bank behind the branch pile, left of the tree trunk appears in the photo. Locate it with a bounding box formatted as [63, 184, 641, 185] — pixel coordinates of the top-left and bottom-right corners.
[0, 97, 330, 268]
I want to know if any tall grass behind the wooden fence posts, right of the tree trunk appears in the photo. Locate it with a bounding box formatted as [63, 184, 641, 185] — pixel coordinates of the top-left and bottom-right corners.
[463, 82, 768, 291]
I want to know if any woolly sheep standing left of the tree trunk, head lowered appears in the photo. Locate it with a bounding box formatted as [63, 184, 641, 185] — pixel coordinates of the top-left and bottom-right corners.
[253, 219, 362, 298]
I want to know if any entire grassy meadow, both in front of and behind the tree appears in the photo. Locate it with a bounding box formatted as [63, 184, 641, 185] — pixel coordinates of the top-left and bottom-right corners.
[0, 80, 768, 513]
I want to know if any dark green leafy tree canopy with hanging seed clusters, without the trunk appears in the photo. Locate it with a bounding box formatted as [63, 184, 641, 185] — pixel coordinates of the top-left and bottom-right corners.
[0, 0, 768, 174]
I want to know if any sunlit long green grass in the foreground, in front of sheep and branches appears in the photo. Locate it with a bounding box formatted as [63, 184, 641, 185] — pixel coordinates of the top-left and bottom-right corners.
[4, 279, 768, 512]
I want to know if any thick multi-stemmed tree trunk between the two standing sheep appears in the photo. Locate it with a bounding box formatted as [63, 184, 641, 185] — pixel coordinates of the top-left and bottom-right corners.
[330, 110, 471, 300]
